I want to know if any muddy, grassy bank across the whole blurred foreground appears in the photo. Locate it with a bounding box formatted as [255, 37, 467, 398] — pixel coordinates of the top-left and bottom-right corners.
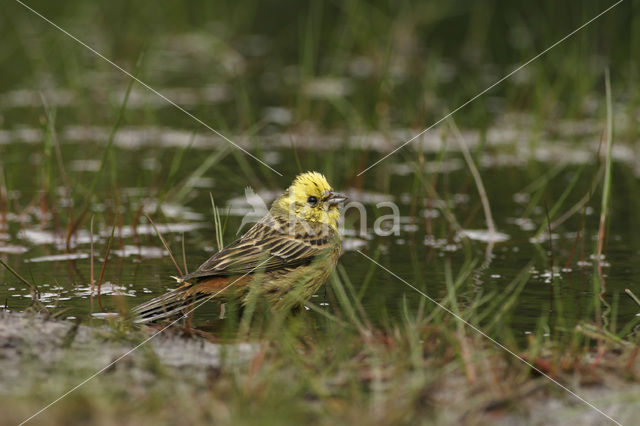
[0, 312, 640, 425]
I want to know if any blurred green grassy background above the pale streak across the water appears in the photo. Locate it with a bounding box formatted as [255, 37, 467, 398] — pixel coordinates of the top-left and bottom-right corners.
[0, 0, 640, 132]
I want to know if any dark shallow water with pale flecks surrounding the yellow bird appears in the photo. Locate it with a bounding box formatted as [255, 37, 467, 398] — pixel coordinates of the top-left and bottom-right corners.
[0, 130, 640, 336]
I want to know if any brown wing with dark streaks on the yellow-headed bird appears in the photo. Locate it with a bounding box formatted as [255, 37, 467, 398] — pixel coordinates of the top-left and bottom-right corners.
[182, 214, 335, 281]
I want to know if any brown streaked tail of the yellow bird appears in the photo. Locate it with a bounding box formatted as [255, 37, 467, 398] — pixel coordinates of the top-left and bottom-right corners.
[130, 285, 211, 324]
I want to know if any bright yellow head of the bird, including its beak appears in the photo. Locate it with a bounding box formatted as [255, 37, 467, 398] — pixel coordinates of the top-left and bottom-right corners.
[271, 172, 347, 230]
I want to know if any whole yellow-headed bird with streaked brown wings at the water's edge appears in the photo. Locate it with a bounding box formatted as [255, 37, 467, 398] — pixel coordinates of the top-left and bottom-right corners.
[130, 171, 347, 323]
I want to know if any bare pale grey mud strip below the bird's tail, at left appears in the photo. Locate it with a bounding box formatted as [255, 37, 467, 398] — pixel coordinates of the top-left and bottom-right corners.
[0, 312, 255, 393]
